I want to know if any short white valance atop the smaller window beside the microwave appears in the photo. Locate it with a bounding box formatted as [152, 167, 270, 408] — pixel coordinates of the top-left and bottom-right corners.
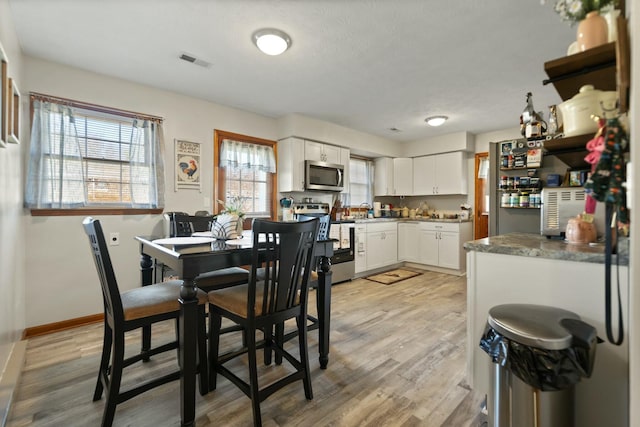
[219, 139, 276, 173]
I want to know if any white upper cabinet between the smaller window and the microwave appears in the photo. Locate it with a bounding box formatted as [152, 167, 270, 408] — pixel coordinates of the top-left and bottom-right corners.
[278, 137, 305, 193]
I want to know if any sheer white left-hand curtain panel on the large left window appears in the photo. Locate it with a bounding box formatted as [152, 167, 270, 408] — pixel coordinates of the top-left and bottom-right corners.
[25, 100, 87, 209]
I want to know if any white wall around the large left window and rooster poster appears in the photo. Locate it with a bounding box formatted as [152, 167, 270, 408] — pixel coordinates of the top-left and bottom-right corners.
[23, 55, 277, 327]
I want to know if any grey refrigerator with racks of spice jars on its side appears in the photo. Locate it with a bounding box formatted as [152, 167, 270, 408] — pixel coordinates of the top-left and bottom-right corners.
[488, 138, 568, 236]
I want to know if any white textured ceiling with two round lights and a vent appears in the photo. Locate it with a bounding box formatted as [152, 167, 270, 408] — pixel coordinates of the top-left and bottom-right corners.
[10, 0, 575, 141]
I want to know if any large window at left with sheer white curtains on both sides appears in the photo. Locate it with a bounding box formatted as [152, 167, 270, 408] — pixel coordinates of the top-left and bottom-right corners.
[25, 94, 164, 214]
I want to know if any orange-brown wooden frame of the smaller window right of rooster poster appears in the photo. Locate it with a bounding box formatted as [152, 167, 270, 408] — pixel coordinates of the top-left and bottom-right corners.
[213, 129, 278, 229]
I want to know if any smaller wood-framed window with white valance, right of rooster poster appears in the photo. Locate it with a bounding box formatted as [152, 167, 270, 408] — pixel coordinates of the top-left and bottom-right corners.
[214, 130, 277, 225]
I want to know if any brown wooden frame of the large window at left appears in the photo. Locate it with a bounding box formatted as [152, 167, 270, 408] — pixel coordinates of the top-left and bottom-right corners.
[28, 96, 164, 216]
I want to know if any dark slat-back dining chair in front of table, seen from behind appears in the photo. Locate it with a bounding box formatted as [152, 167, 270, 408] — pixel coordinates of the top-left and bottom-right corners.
[209, 219, 319, 426]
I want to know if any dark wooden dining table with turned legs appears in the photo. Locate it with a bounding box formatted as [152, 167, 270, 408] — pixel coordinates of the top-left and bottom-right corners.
[135, 236, 335, 426]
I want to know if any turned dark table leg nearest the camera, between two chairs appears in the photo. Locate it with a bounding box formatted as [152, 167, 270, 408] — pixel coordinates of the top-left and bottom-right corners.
[178, 279, 198, 427]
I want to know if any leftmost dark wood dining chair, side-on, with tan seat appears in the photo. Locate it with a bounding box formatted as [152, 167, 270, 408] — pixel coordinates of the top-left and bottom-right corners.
[82, 217, 209, 427]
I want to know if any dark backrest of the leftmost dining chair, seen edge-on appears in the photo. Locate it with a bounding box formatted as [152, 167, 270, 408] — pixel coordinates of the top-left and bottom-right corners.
[82, 217, 124, 325]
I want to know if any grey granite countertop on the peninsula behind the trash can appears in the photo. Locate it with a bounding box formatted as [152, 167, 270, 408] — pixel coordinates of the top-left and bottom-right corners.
[464, 233, 629, 265]
